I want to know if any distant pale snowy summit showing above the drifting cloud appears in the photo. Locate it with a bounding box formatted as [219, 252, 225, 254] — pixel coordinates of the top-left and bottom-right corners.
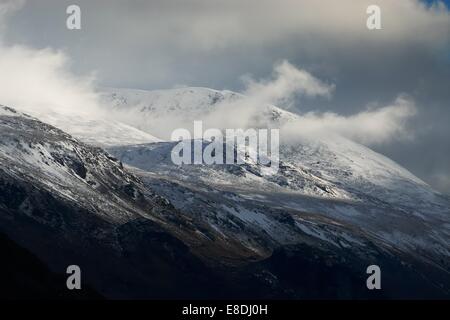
[101, 87, 297, 140]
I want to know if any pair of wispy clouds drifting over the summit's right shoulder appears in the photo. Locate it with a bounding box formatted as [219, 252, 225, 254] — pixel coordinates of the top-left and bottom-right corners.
[207, 61, 416, 145]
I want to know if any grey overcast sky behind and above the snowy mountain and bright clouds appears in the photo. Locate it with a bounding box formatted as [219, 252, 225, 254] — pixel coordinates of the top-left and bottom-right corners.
[0, 0, 450, 193]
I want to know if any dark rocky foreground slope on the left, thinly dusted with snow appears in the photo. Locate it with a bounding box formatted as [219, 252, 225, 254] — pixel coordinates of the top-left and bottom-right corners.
[0, 107, 243, 298]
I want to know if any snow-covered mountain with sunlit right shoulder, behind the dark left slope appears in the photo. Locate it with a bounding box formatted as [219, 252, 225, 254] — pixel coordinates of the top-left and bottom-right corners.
[99, 88, 450, 292]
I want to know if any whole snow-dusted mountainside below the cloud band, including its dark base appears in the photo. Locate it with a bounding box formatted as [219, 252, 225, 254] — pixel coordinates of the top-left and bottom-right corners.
[0, 92, 450, 298]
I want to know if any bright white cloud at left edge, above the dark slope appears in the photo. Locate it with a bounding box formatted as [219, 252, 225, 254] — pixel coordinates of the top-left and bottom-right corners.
[0, 46, 101, 113]
